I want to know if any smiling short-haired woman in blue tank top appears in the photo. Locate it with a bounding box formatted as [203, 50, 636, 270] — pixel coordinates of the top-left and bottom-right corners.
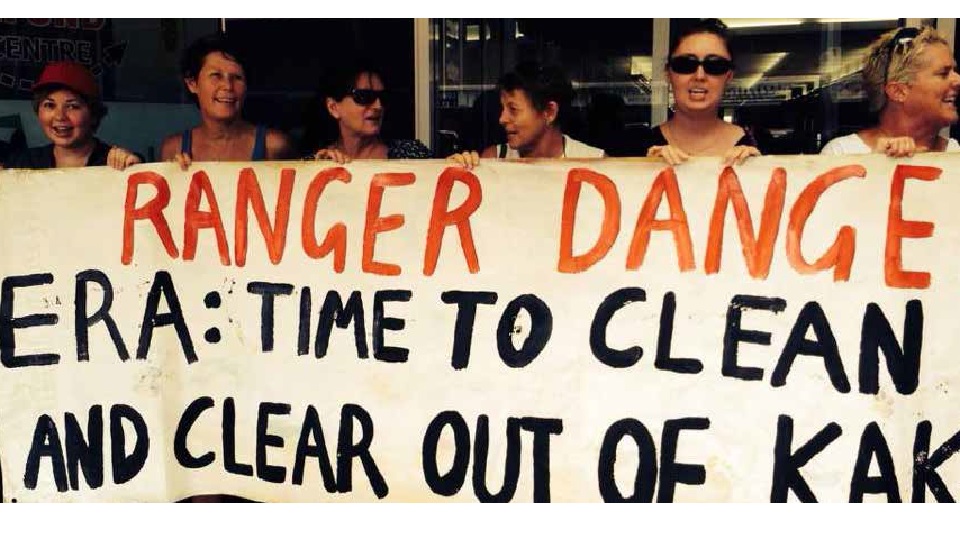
[160, 35, 291, 169]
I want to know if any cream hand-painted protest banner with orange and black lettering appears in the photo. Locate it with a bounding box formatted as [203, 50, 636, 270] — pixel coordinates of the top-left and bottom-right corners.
[0, 155, 960, 501]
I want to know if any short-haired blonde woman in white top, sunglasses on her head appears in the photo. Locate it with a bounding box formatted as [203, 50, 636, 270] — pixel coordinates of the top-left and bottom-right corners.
[820, 27, 960, 157]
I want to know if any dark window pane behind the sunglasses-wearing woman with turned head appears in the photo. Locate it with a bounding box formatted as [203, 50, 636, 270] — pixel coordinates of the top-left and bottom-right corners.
[226, 19, 414, 155]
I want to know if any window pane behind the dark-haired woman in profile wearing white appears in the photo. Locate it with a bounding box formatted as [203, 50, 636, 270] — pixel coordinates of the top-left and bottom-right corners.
[431, 19, 653, 156]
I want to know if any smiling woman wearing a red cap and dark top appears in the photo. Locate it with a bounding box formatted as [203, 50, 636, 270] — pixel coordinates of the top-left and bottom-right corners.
[6, 62, 143, 171]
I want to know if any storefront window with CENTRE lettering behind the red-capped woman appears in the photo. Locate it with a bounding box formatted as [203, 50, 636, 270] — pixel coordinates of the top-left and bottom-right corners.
[0, 18, 220, 160]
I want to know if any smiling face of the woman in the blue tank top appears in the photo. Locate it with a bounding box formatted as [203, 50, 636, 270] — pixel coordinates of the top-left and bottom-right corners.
[185, 51, 247, 120]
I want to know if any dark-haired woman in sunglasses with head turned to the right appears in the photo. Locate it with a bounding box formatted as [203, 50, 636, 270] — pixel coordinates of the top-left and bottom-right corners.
[308, 62, 433, 163]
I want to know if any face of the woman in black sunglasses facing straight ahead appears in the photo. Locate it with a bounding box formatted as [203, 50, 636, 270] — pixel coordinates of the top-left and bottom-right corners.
[668, 33, 733, 112]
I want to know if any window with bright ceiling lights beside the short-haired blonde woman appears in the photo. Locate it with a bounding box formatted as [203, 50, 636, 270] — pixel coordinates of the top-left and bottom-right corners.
[692, 19, 899, 154]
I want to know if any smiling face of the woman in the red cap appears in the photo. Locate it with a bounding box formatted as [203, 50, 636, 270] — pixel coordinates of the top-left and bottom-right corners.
[37, 88, 94, 148]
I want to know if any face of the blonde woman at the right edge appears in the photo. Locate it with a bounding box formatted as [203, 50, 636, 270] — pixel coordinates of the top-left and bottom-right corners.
[895, 43, 960, 126]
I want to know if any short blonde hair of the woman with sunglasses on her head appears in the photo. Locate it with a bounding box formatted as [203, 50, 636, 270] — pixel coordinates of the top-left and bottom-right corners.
[863, 26, 950, 112]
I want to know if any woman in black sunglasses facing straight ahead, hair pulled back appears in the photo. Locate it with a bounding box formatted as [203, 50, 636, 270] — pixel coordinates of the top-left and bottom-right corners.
[611, 19, 760, 165]
